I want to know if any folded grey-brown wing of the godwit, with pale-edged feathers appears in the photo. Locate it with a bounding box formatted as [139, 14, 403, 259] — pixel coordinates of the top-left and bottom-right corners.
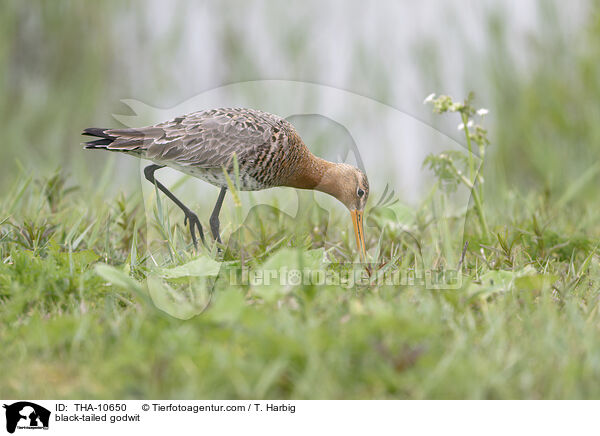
[105, 108, 284, 168]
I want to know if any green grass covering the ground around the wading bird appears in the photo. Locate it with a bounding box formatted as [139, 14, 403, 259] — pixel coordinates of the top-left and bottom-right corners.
[0, 165, 600, 398]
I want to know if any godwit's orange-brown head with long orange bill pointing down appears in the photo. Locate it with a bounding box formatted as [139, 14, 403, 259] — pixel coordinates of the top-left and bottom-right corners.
[317, 163, 369, 262]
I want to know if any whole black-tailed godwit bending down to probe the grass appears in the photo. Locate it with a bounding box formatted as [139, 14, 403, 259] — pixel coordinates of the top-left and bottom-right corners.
[83, 108, 369, 261]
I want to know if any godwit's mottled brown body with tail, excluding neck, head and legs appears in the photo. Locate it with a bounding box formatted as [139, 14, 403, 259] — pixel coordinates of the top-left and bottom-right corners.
[85, 108, 310, 190]
